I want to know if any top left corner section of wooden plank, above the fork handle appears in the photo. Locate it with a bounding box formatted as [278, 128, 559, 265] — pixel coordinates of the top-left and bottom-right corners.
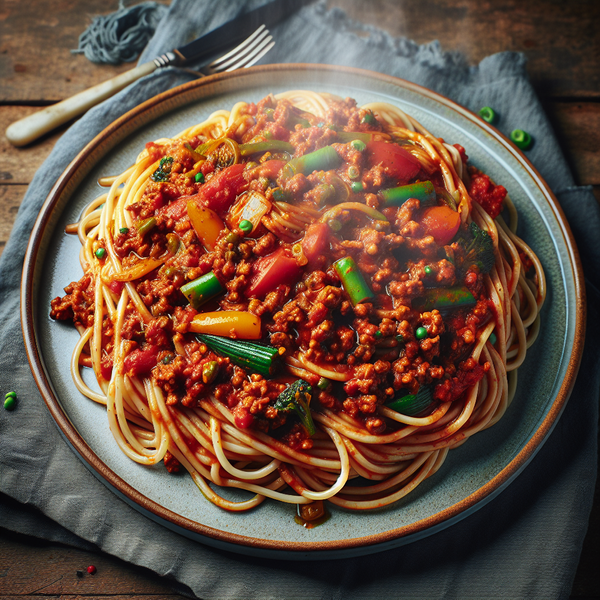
[0, 0, 169, 105]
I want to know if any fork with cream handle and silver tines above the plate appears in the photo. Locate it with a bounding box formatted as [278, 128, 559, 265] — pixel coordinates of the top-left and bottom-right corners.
[6, 25, 275, 146]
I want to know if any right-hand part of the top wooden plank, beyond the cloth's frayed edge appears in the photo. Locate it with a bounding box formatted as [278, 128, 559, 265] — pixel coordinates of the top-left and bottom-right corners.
[329, 0, 600, 98]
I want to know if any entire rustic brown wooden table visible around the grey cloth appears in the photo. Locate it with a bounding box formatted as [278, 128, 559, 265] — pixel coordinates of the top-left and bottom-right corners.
[0, 0, 600, 599]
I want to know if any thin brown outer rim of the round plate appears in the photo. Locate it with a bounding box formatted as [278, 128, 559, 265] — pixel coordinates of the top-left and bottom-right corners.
[21, 63, 586, 558]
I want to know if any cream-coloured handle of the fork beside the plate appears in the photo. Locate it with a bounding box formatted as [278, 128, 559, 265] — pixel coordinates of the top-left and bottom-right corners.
[6, 62, 157, 146]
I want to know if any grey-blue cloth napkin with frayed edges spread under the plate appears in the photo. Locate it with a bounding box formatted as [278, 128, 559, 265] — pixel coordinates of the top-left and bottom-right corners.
[0, 0, 600, 600]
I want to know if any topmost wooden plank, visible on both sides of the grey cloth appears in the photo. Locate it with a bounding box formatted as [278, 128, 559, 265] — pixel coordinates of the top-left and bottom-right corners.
[0, 0, 600, 103]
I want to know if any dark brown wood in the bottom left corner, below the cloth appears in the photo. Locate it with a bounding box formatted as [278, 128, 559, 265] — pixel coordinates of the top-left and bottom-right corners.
[0, 529, 188, 600]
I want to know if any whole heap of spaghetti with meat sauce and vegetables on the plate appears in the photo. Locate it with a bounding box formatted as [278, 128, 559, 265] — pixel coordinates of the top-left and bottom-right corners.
[51, 91, 545, 511]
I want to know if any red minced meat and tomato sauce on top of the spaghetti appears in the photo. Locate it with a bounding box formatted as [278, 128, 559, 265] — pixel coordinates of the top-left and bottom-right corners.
[51, 96, 506, 454]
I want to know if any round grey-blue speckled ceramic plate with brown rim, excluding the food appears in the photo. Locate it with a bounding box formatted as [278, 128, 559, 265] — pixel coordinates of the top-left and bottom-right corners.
[22, 65, 585, 560]
